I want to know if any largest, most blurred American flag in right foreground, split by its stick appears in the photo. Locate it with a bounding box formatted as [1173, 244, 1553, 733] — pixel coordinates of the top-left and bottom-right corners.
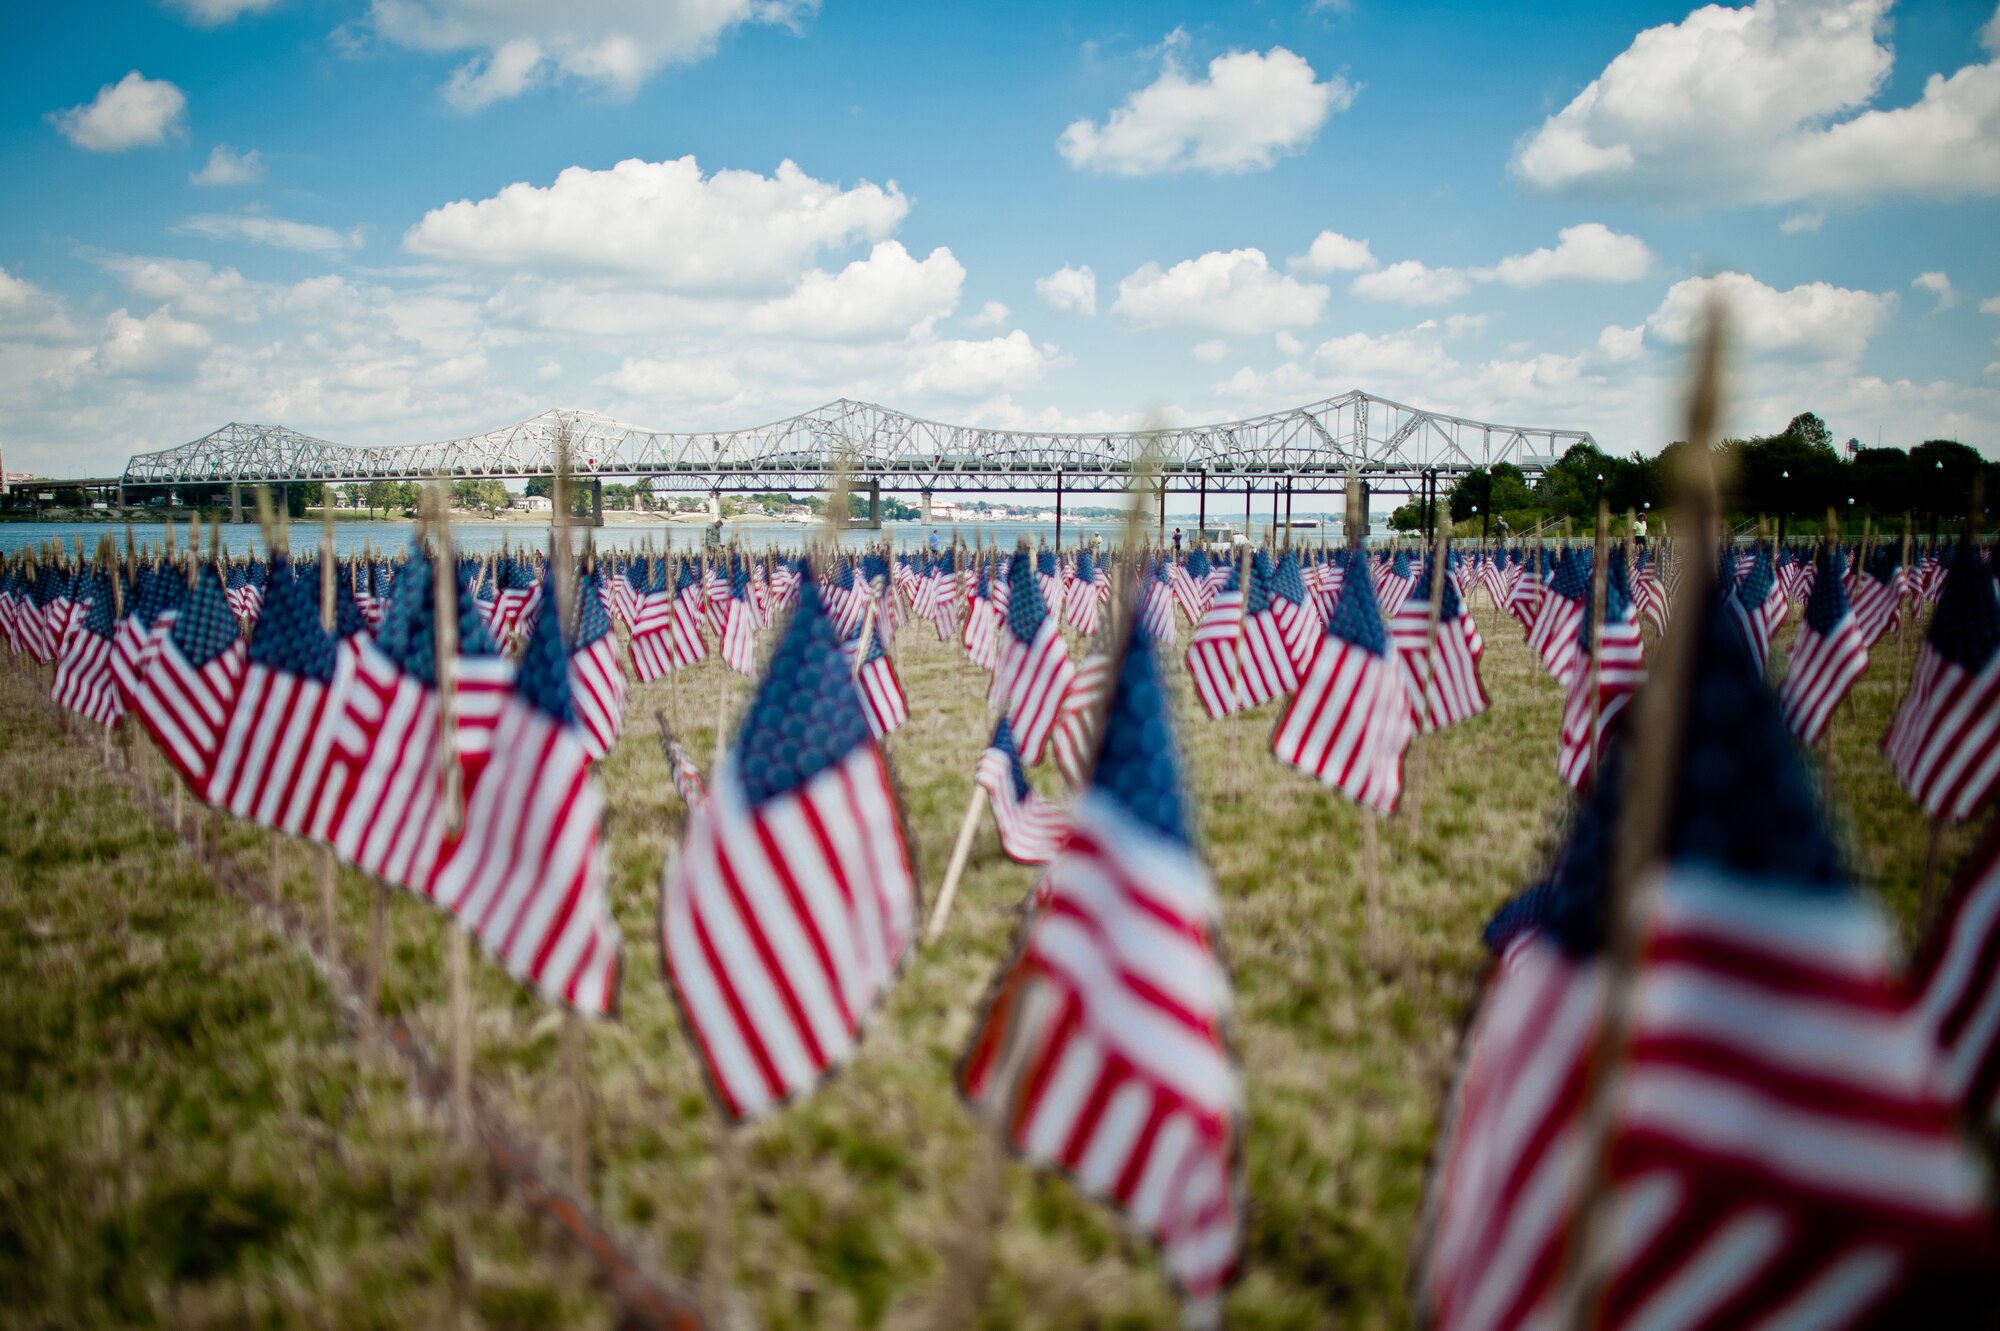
[1416, 612, 1990, 1331]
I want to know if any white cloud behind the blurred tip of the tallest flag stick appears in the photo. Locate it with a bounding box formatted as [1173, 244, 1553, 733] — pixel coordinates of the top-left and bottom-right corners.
[1646, 272, 1896, 362]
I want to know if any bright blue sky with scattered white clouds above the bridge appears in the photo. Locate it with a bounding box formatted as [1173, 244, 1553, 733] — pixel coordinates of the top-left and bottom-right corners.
[0, 0, 2000, 474]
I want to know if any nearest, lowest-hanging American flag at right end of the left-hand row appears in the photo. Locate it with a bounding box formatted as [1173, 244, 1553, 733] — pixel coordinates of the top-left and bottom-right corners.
[428, 587, 624, 1017]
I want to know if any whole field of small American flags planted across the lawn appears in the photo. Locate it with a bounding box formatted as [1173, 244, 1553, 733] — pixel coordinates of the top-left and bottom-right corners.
[0, 523, 2000, 1327]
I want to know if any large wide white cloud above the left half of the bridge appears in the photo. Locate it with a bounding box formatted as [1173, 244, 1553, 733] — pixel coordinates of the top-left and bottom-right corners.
[402, 156, 910, 290]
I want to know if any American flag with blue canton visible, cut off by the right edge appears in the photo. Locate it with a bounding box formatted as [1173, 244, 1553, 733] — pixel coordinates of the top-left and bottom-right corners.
[1882, 542, 2000, 823]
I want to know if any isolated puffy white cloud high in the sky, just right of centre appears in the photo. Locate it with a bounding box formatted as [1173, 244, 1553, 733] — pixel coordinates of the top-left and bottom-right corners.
[1056, 38, 1356, 176]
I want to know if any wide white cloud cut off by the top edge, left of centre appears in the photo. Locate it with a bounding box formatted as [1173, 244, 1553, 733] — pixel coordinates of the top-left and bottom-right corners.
[372, 0, 818, 110]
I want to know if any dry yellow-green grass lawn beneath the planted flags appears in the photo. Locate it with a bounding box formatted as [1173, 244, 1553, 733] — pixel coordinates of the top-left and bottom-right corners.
[0, 598, 1974, 1329]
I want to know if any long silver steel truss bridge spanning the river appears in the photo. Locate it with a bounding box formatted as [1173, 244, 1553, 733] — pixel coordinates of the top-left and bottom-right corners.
[122, 392, 1594, 503]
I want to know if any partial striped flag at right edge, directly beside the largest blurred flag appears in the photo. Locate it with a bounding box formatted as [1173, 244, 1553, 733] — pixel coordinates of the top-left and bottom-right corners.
[1908, 833, 2000, 1127]
